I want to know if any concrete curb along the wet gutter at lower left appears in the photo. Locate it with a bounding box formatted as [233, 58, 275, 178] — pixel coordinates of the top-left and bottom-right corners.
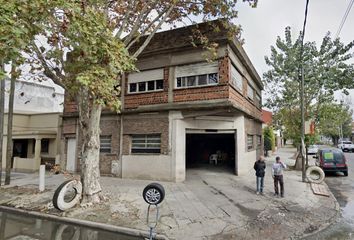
[0, 205, 169, 240]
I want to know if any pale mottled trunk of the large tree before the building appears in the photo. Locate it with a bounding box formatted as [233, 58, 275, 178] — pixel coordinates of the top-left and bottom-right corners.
[78, 89, 102, 203]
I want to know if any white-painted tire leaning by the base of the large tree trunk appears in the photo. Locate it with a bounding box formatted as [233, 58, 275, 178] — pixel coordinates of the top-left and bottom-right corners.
[53, 180, 82, 211]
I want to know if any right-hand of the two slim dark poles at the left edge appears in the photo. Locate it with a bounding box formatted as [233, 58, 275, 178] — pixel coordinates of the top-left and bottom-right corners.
[5, 63, 16, 185]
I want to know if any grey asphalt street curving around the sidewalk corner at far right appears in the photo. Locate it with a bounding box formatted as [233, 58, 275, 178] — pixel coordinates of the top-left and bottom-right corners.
[307, 153, 354, 240]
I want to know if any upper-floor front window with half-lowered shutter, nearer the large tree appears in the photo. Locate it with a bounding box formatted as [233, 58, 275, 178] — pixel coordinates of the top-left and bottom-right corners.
[128, 68, 164, 93]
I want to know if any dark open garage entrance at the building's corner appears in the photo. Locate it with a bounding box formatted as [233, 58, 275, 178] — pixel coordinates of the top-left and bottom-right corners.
[186, 133, 235, 171]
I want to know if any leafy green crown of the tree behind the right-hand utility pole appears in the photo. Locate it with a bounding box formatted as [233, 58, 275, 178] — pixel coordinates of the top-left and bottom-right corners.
[263, 27, 354, 167]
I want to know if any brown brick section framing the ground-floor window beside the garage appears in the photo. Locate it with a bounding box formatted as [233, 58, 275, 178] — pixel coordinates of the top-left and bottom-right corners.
[123, 113, 169, 155]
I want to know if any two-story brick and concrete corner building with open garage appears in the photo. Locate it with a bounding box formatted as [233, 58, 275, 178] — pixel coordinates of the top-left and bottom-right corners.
[62, 20, 263, 181]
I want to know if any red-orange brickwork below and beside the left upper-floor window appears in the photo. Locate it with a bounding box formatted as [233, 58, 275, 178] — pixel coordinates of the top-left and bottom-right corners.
[124, 67, 169, 109]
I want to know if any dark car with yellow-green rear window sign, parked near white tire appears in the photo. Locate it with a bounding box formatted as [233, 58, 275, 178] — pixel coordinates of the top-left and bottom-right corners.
[315, 148, 348, 176]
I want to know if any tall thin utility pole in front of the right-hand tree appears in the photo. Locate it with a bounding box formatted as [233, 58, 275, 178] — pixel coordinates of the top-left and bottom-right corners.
[300, 0, 309, 182]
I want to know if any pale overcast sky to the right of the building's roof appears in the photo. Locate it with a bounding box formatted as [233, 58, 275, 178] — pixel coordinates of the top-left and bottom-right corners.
[236, 0, 354, 117]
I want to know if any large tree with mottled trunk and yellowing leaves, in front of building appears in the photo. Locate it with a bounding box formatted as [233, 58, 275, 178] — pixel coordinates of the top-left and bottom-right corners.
[0, 0, 257, 202]
